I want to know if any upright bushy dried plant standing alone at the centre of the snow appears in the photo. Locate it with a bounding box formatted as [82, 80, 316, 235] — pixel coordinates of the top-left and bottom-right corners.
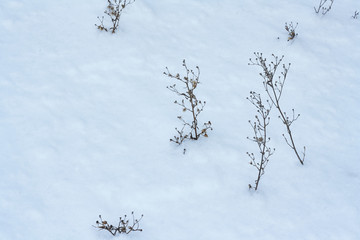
[164, 60, 212, 145]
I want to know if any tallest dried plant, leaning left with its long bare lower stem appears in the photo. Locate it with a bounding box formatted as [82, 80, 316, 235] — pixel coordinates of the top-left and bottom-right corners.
[249, 52, 305, 165]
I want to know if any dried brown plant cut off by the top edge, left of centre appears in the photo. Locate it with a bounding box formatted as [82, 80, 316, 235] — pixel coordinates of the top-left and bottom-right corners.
[95, 0, 135, 33]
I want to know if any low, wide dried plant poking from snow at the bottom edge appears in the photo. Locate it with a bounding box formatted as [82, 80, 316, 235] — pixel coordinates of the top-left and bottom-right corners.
[94, 212, 144, 236]
